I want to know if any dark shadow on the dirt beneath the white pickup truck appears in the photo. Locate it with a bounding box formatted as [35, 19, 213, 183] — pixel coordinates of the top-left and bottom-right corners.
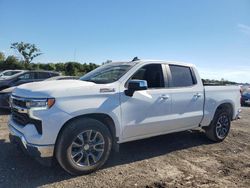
[0, 131, 212, 187]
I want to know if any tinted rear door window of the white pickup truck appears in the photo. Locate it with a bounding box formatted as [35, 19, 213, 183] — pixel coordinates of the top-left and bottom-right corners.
[169, 65, 196, 87]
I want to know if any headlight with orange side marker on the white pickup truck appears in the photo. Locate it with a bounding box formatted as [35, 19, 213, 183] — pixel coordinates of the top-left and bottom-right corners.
[26, 98, 55, 110]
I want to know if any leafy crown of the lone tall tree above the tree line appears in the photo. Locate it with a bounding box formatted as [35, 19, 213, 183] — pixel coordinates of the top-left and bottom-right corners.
[10, 42, 42, 64]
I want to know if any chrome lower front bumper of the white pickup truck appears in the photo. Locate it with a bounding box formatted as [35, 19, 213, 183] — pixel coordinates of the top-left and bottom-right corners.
[9, 124, 54, 166]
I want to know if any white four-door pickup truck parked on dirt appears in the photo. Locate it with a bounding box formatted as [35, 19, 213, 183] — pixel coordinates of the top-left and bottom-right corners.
[9, 60, 240, 175]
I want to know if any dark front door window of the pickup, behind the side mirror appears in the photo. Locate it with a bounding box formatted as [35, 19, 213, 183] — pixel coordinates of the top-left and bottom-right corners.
[131, 64, 164, 88]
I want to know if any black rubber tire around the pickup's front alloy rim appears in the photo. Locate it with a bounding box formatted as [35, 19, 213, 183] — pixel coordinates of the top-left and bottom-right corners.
[55, 118, 112, 175]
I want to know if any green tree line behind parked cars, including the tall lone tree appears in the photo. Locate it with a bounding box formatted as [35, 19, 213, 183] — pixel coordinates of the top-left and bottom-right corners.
[0, 42, 99, 76]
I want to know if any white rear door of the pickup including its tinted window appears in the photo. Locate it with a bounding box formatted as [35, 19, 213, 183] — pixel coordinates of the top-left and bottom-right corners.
[166, 64, 204, 129]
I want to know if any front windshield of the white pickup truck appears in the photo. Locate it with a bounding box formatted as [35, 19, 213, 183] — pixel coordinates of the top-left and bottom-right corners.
[80, 63, 134, 84]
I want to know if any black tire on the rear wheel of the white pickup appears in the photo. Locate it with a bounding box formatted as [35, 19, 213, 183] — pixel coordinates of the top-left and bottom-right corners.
[204, 109, 231, 142]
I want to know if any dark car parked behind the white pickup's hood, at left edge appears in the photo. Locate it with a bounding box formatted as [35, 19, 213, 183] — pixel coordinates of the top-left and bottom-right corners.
[0, 70, 60, 109]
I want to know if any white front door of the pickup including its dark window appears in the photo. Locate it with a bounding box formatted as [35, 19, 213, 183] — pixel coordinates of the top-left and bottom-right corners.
[121, 64, 171, 139]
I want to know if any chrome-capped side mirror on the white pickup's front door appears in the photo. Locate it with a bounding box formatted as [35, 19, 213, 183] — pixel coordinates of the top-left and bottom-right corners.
[125, 80, 148, 97]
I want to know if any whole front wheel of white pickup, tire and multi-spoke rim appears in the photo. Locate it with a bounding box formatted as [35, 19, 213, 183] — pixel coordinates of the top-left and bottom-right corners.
[56, 118, 112, 175]
